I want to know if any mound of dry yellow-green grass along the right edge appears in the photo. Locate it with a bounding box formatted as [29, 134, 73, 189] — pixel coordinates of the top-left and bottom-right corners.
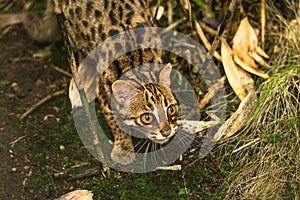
[218, 1, 300, 199]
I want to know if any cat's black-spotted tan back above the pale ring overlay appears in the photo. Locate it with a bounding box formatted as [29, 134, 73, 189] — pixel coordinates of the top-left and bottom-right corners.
[61, 0, 153, 53]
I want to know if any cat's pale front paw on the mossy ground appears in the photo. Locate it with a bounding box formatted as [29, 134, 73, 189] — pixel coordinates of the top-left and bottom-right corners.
[111, 145, 135, 165]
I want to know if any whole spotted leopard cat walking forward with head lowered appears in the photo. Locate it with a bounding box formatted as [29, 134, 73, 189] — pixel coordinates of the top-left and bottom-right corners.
[54, 0, 179, 165]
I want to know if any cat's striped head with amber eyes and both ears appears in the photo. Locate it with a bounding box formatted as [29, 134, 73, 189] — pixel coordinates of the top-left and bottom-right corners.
[112, 65, 179, 144]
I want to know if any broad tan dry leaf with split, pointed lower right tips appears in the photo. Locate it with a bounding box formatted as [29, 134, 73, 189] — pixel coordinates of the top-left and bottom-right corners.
[232, 17, 269, 78]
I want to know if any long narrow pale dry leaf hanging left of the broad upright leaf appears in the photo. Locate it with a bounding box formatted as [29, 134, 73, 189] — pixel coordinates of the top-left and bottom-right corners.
[221, 38, 254, 101]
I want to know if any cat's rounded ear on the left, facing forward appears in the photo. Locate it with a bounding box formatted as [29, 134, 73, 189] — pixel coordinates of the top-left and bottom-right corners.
[112, 80, 135, 105]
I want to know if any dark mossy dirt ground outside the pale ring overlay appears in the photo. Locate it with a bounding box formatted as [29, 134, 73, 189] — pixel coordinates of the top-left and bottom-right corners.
[0, 23, 226, 200]
